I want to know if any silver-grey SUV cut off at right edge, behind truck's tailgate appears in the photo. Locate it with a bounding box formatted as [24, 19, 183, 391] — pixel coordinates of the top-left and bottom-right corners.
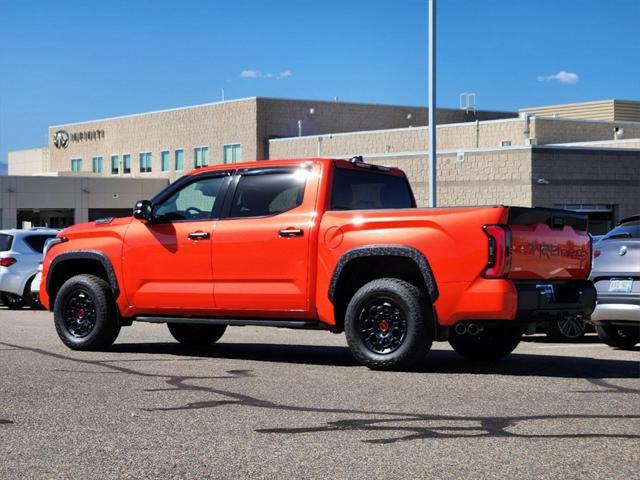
[591, 215, 640, 348]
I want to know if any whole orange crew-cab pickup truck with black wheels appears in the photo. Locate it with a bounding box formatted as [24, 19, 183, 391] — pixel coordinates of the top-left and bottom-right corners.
[40, 157, 596, 369]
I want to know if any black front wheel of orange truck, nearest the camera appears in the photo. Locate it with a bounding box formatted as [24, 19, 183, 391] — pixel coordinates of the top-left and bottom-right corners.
[53, 275, 120, 350]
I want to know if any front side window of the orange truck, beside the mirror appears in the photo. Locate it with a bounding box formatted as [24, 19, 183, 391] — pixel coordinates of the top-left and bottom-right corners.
[154, 176, 227, 222]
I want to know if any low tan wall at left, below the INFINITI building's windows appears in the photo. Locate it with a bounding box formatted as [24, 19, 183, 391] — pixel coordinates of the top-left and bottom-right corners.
[0, 176, 168, 228]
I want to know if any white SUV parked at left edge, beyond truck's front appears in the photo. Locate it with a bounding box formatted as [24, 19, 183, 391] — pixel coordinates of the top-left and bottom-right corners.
[0, 228, 59, 309]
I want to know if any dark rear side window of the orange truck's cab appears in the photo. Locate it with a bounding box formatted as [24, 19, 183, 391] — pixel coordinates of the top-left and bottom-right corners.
[231, 170, 306, 217]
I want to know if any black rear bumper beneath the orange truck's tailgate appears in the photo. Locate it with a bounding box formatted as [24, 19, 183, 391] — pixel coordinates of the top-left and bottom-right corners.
[515, 281, 596, 322]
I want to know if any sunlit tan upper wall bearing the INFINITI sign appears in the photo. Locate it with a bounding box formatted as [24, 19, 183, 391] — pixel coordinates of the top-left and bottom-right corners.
[49, 98, 257, 179]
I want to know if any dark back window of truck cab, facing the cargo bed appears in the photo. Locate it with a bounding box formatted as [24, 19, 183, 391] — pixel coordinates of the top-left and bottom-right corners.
[331, 168, 415, 210]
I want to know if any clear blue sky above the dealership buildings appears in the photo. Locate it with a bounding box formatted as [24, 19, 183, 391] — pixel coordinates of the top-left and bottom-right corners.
[0, 0, 640, 171]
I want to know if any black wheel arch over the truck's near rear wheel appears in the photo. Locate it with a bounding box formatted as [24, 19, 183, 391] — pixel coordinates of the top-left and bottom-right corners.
[333, 255, 430, 331]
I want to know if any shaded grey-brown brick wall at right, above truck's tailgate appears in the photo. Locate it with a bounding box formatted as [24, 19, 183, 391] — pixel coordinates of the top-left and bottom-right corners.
[532, 147, 640, 220]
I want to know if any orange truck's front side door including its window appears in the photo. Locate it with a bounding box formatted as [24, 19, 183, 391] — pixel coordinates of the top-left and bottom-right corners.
[122, 172, 231, 314]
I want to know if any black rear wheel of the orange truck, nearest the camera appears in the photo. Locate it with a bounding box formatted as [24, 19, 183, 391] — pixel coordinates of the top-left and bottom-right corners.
[344, 278, 434, 370]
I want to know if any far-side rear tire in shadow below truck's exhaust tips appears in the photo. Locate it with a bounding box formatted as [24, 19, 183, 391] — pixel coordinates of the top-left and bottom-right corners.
[449, 325, 523, 360]
